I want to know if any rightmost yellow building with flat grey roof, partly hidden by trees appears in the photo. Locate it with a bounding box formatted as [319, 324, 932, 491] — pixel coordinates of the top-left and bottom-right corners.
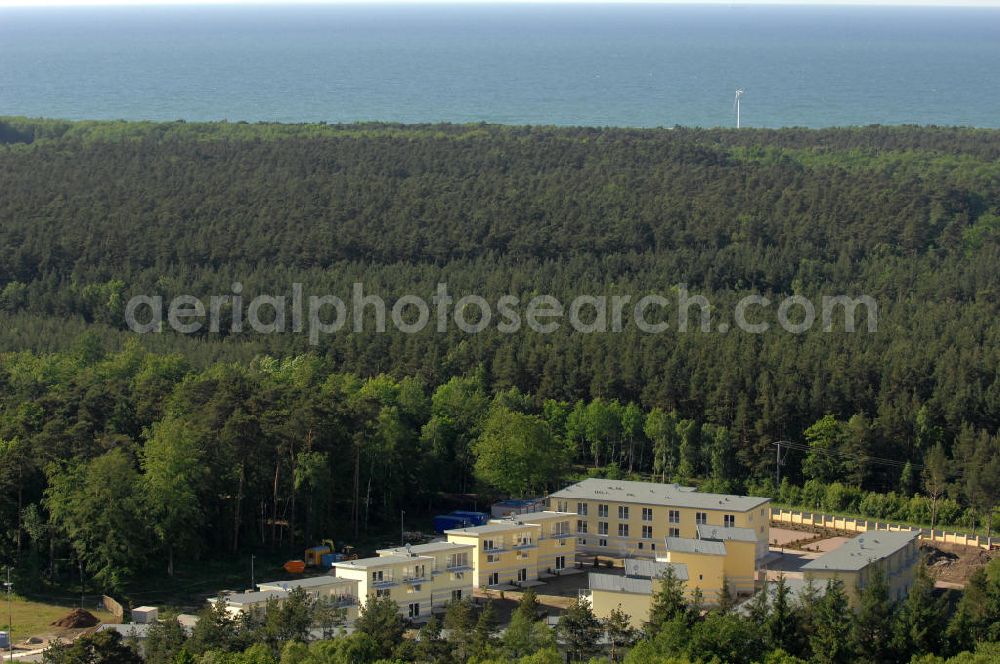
[802, 530, 920, 607]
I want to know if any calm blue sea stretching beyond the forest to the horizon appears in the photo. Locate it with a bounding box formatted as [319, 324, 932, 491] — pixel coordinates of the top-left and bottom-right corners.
[0, 5, 1000, 127]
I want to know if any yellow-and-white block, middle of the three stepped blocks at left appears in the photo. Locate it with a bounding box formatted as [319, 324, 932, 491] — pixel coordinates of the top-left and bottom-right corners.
[335, 547, 472, 621]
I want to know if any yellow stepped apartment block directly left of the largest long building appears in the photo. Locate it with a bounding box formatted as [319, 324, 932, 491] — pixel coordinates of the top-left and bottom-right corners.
[445, 512, 576, 588]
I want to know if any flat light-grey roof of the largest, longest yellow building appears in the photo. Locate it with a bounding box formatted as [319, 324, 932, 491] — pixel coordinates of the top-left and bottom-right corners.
[549, 477, 771, 512]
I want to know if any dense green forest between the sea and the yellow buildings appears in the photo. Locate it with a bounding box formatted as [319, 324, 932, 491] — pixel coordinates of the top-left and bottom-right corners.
[0, 118, 1000, 588]
